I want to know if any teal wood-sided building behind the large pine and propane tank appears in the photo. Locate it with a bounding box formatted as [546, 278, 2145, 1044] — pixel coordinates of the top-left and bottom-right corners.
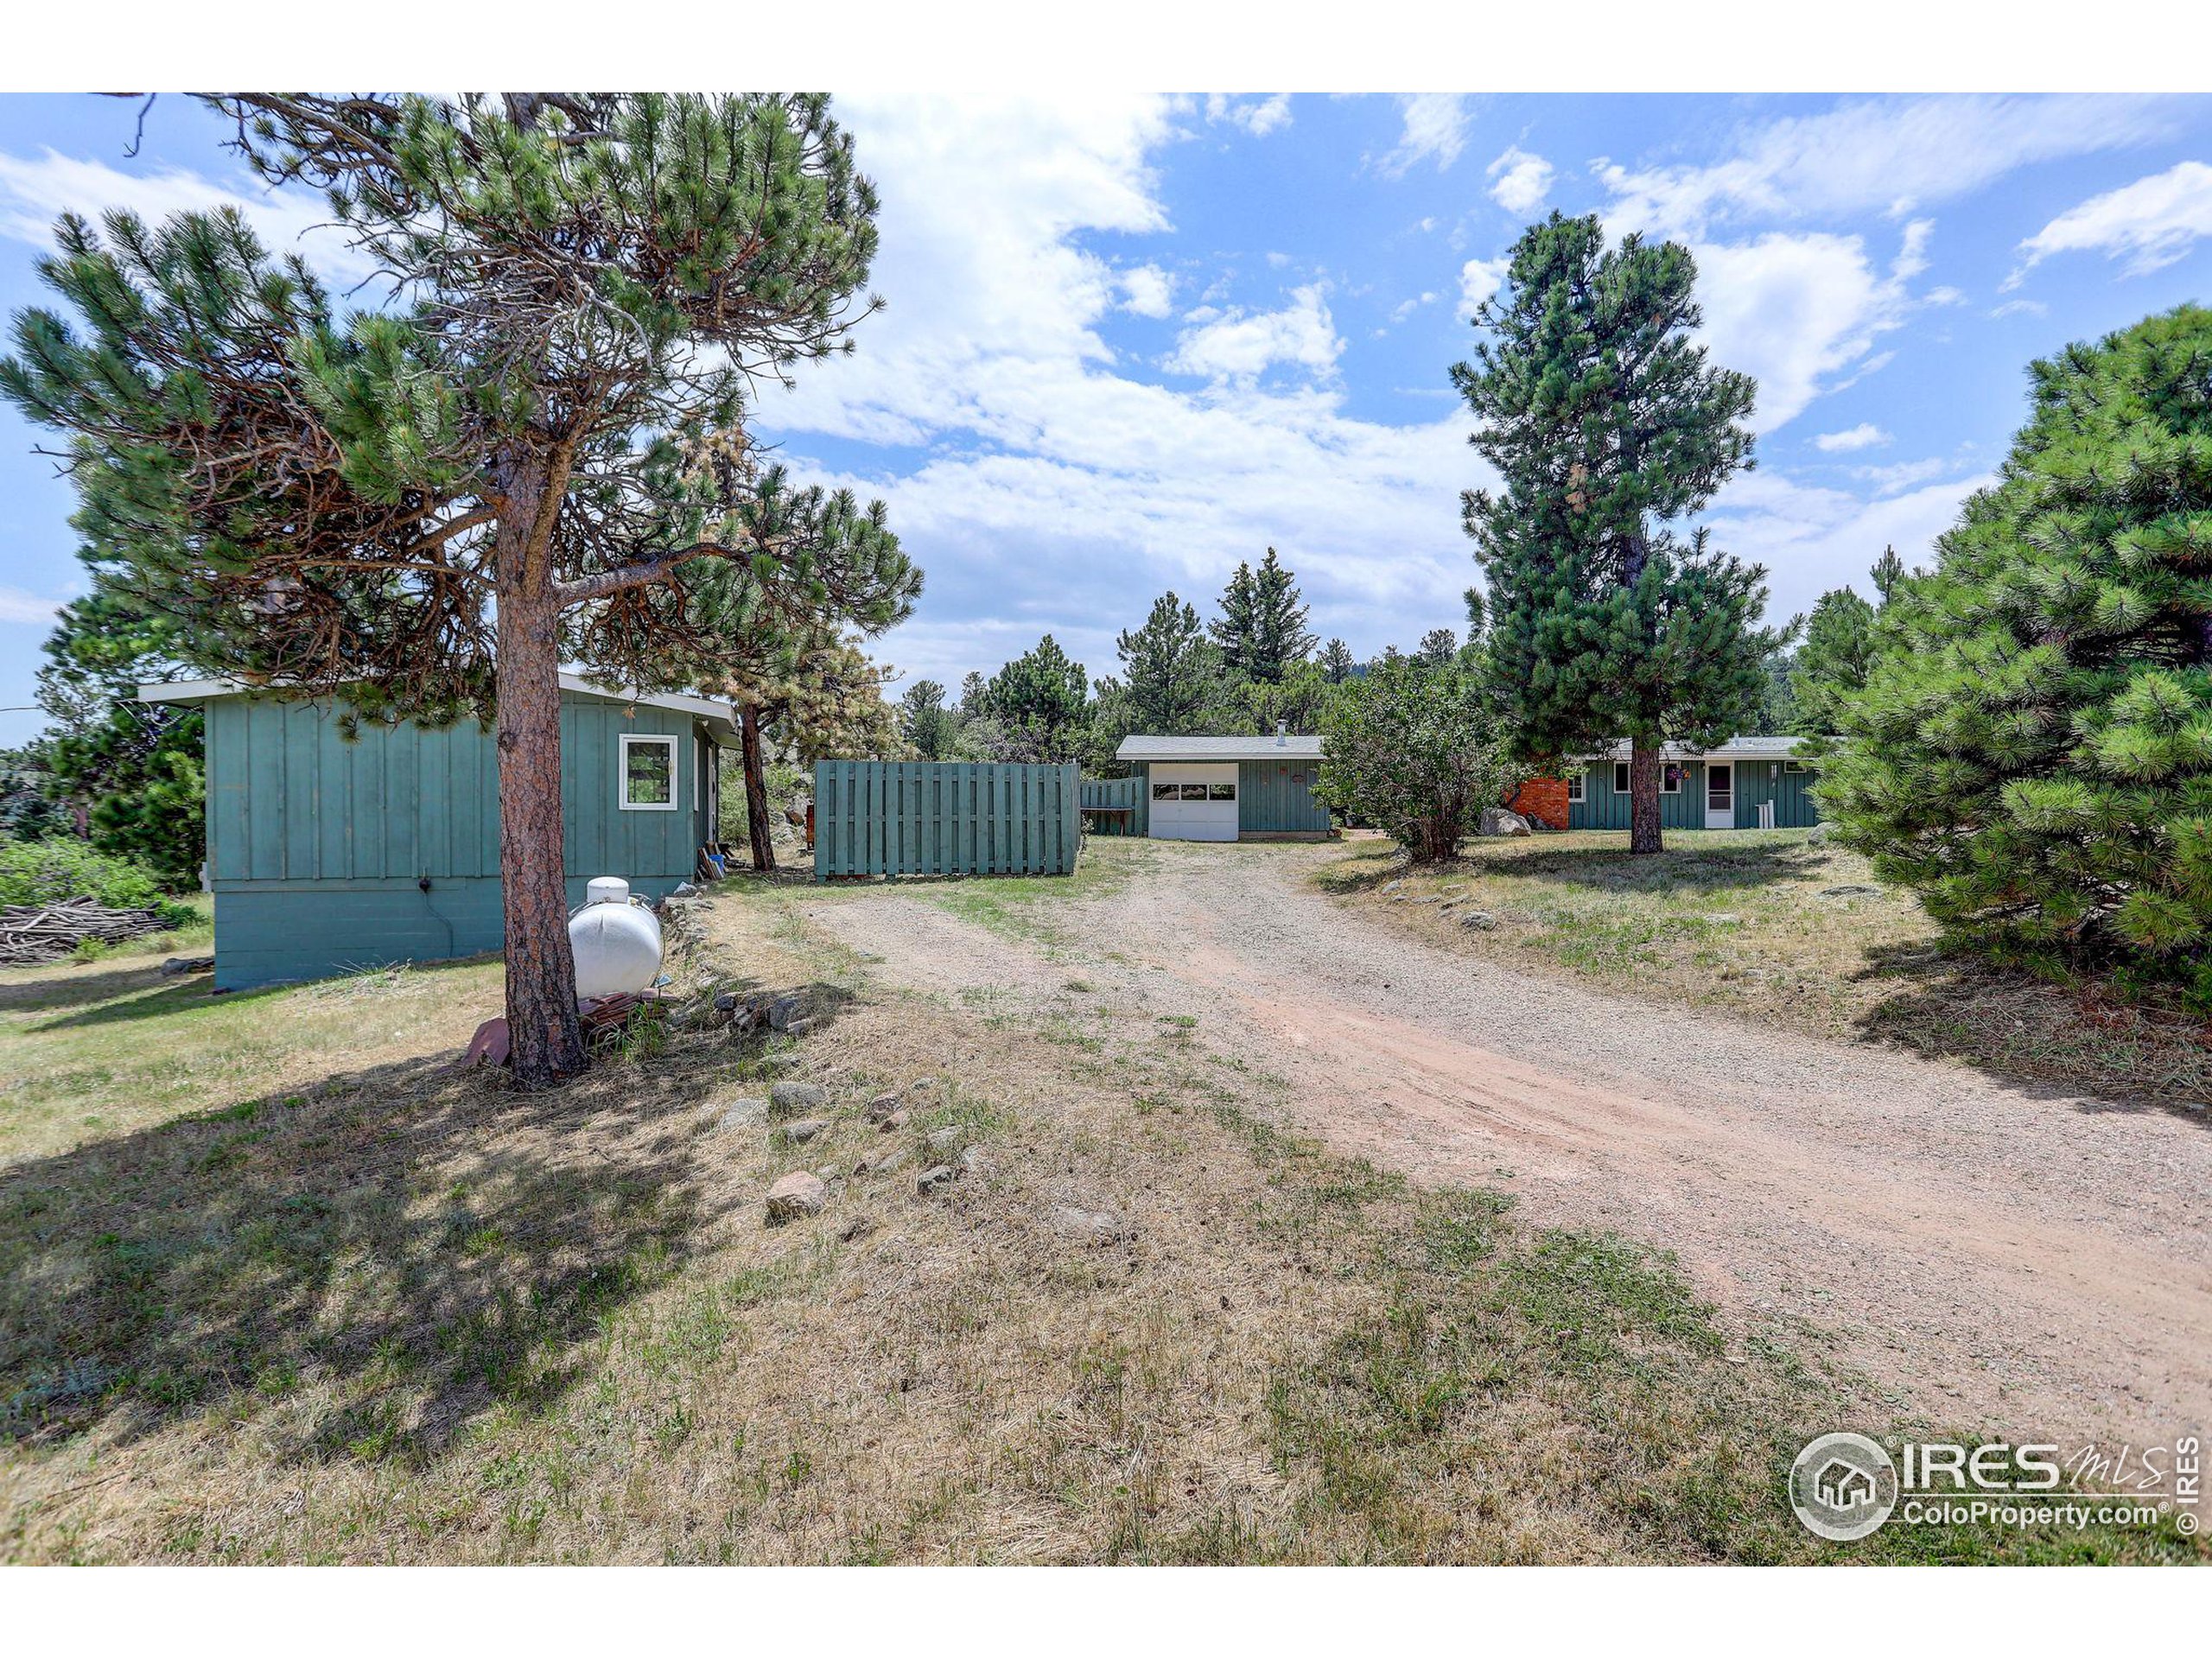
[139, 675, 736, 991]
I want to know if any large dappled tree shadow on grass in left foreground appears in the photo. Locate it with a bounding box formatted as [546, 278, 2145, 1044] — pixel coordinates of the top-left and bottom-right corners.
[0, 987, 845, 1466]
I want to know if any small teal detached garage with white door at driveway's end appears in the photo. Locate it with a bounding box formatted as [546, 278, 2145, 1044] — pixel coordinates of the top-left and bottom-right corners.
[1115, 732, 1334, 841]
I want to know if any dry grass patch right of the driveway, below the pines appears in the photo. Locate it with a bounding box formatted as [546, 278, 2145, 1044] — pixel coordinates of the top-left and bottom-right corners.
[1319, 830, 2212, 1119]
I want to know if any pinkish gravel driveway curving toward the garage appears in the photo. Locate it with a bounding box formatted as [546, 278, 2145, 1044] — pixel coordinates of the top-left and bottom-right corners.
[803, 842, 2212, 1442]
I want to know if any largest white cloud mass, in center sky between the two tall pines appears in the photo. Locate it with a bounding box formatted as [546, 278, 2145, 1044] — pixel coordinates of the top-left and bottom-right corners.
[761, 98, 1486, 683]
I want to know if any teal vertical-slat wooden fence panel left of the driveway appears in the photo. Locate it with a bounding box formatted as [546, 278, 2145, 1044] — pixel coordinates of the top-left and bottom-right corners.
[814, 761, 1082, 880]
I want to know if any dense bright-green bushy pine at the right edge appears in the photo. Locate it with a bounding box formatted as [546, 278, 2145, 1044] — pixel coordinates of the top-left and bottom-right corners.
[1821, 305, 2212, 995]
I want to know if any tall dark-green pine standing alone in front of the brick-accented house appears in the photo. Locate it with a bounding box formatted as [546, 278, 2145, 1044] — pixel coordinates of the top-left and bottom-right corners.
[1451, 213, 1778, 854]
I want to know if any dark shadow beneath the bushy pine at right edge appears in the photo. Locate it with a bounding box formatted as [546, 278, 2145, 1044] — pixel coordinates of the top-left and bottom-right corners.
[1853, 944, 2212, 1128]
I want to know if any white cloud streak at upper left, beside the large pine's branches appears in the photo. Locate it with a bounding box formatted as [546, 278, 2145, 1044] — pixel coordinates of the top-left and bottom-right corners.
[0, 149, 372, 281]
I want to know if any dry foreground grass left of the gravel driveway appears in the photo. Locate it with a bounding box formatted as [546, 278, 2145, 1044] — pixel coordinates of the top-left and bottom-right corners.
[0, 885, 2190, 1561]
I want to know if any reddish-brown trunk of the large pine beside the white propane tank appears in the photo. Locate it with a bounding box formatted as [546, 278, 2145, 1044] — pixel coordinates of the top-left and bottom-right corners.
[498, 499, 588, 1089]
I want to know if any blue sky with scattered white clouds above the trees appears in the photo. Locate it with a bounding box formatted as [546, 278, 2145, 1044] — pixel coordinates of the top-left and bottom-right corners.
[0, 95, 2212, 743]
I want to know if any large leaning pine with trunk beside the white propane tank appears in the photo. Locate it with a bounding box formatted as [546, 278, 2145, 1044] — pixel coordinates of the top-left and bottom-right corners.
[0, 104, 898, 1084]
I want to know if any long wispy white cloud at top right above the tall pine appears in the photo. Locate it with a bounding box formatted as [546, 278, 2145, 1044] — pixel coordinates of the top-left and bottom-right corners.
[1592, 95, 2183, 237]
